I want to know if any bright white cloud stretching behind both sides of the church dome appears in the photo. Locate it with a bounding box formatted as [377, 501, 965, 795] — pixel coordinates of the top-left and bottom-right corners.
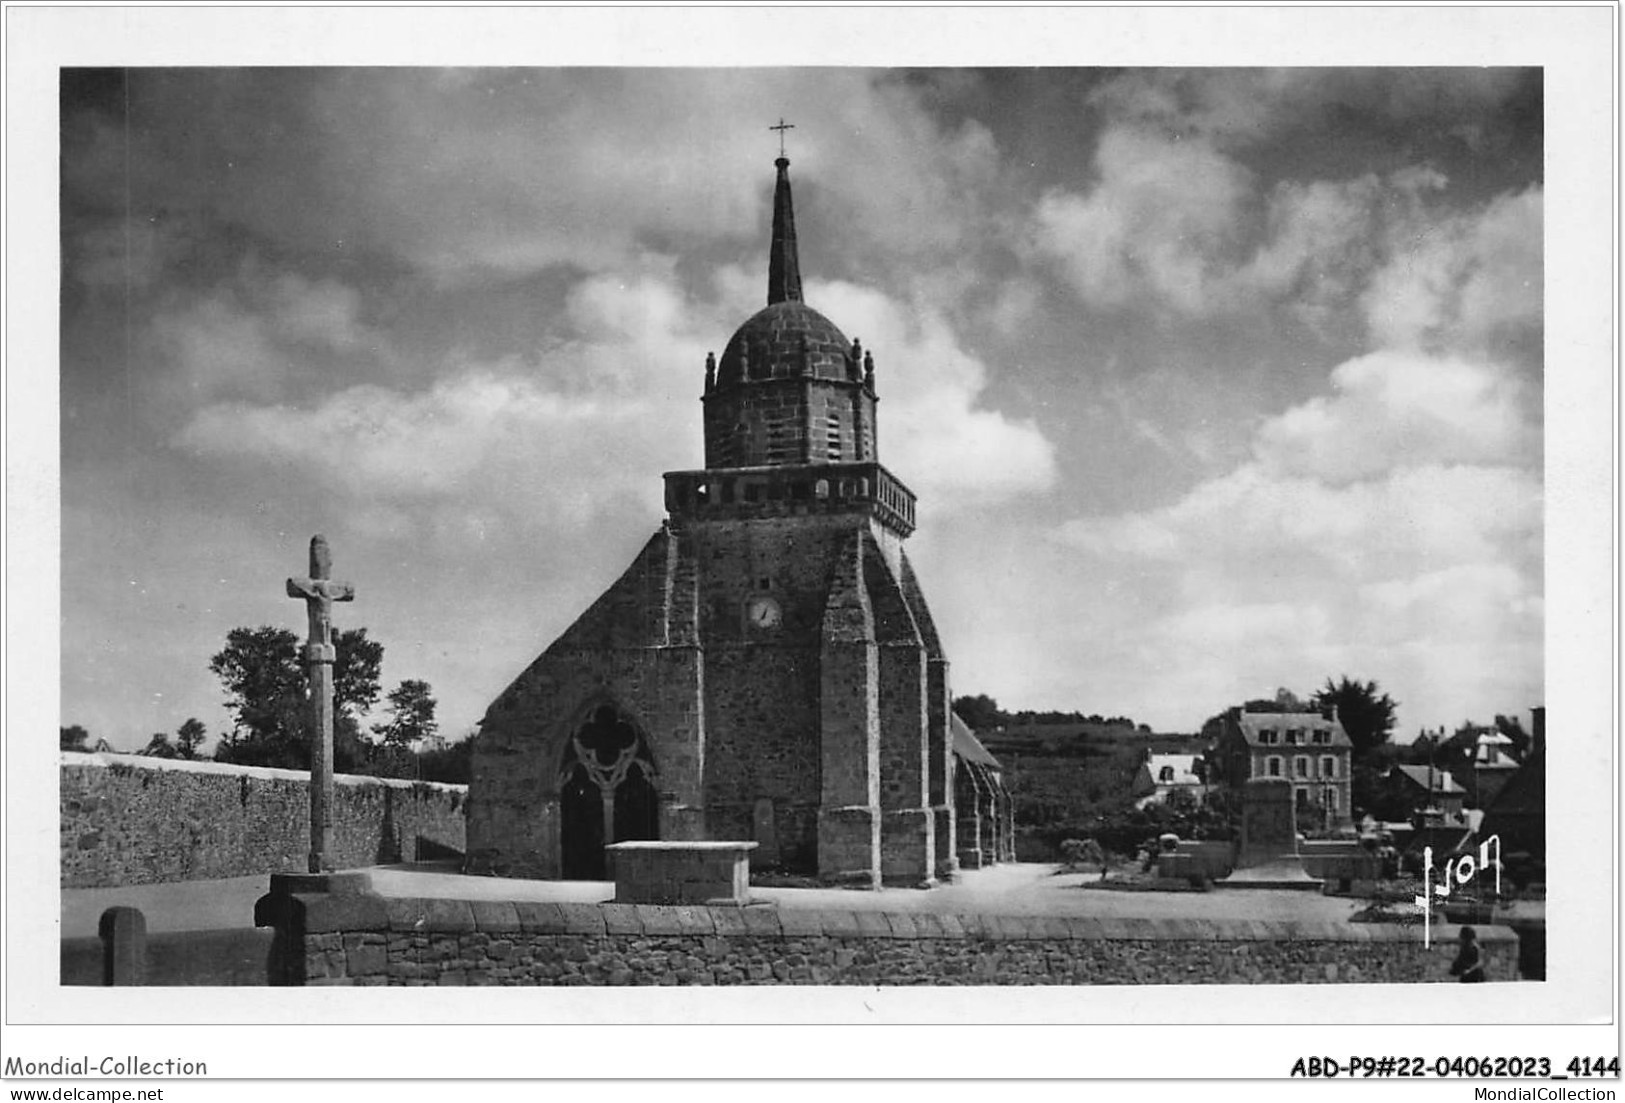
[176, 265, 1055, 530]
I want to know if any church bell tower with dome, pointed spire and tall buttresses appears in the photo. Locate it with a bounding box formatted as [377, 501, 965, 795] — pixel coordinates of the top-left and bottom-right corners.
[666, 156, 957, 884]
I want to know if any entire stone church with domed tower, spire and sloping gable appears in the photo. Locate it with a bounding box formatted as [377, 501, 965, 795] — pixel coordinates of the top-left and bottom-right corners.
[468, 156, 1014, 885]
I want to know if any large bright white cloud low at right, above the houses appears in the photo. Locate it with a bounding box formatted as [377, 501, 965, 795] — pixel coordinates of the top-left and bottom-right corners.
[1060, 344, 1544, 734]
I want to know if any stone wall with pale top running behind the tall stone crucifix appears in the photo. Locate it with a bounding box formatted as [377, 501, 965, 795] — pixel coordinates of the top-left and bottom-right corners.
[60, 752, 468, 889]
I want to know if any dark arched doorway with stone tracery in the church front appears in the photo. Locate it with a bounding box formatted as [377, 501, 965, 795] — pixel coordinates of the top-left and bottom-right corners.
[559, 705, 660, 880]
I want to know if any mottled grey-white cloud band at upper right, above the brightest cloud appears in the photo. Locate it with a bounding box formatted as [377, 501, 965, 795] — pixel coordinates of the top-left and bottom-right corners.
[1027, 107, 1542, 349]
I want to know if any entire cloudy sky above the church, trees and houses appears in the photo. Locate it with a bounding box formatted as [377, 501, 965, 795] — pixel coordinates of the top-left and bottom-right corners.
[60, 68, 1545, 747]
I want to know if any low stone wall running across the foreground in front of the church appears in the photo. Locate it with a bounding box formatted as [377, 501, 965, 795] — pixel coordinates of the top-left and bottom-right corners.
[257, 893, 1518, 984]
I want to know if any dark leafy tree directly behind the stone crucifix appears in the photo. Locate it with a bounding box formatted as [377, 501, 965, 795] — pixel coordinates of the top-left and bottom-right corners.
[210, 627, 384, 772]
